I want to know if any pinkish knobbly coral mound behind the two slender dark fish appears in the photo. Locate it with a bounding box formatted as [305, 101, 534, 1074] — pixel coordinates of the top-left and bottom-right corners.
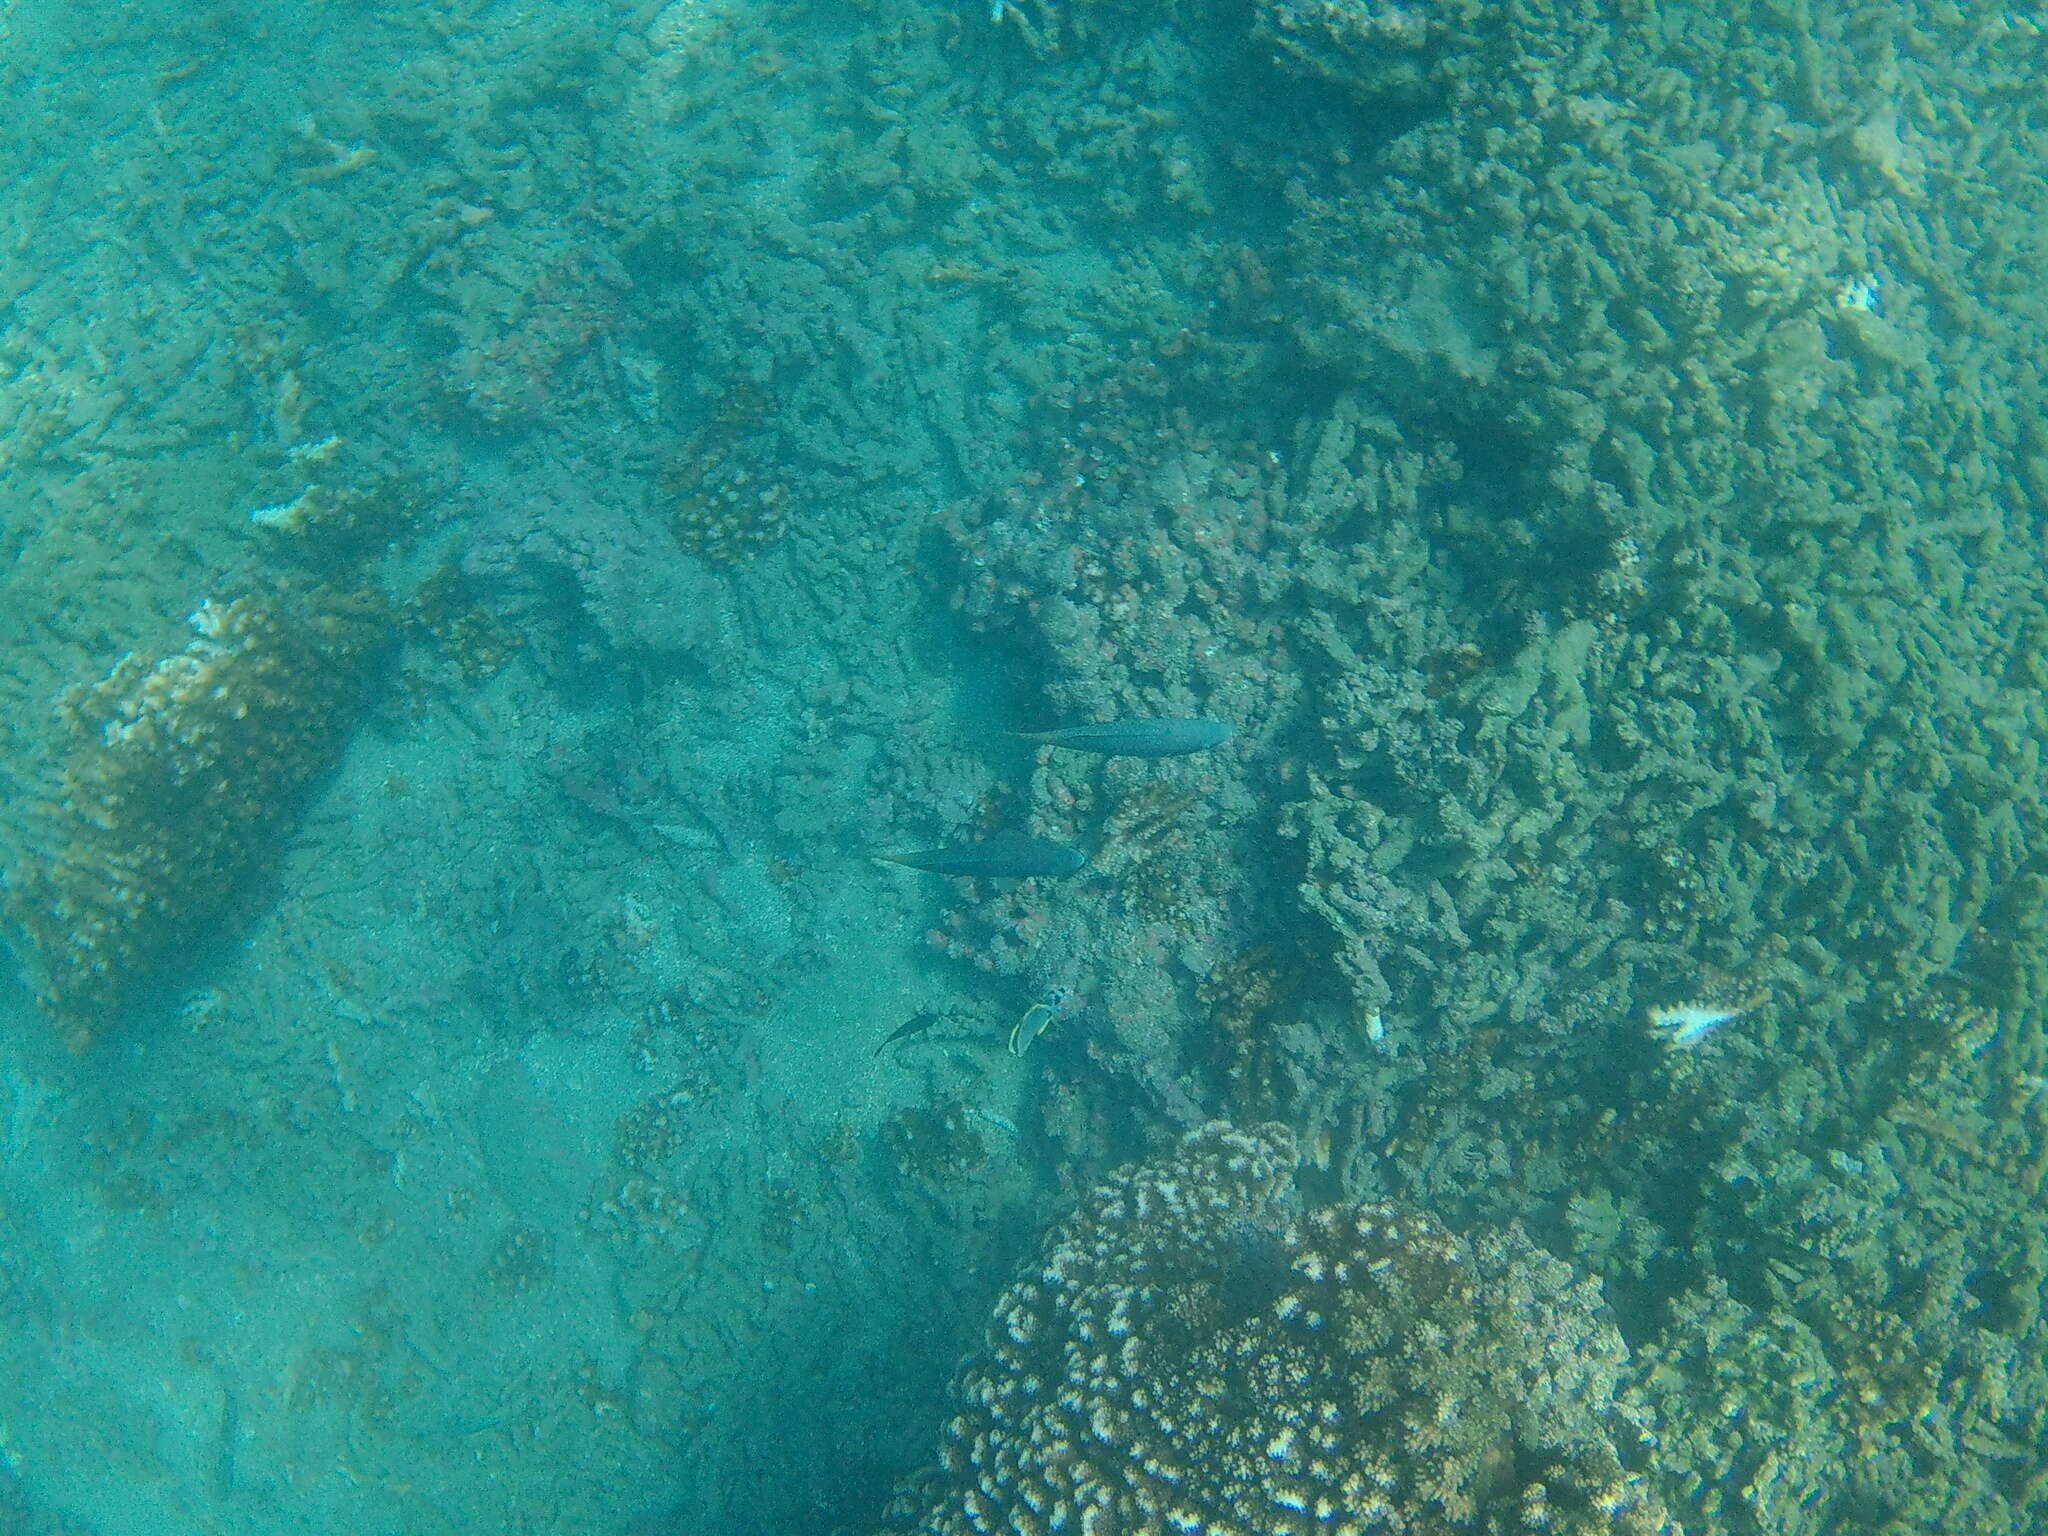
[942, 354, 1317, 1126]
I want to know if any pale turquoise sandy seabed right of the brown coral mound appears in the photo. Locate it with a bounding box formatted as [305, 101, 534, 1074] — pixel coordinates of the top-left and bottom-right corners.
[0, 499, 1034, 1536]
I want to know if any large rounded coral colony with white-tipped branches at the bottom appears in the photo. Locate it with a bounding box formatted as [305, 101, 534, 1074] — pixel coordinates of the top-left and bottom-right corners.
[885, 1122, 1673, 1536]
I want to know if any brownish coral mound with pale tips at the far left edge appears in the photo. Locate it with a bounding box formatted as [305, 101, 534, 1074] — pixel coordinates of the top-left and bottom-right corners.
[6, 588, 385, 1044]
